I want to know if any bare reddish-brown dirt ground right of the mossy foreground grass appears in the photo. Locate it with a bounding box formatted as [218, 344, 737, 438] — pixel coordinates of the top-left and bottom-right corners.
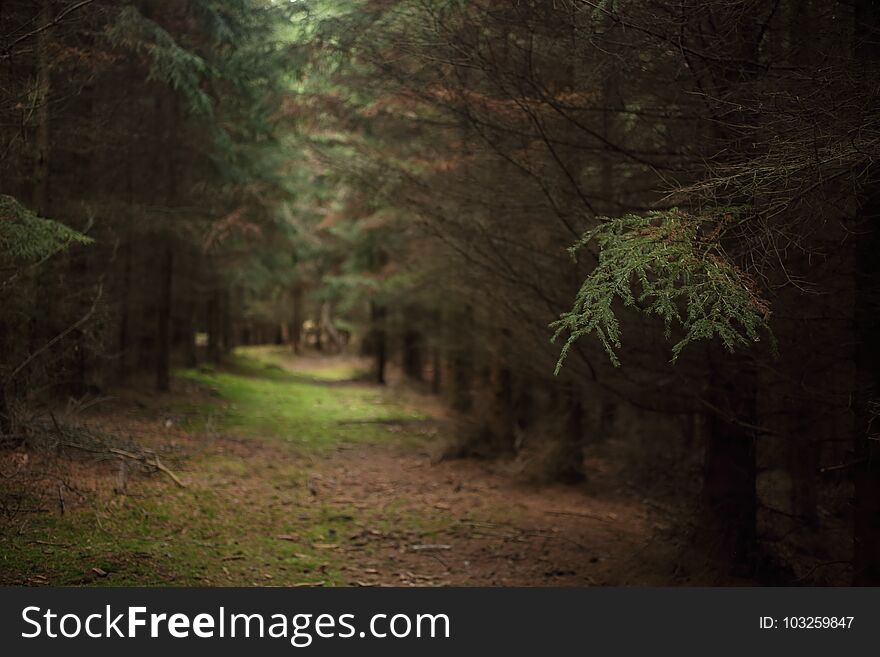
[313, 445, 649, 586]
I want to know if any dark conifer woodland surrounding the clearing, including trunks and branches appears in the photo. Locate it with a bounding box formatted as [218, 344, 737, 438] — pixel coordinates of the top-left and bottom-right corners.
[0, 0, 880, 585]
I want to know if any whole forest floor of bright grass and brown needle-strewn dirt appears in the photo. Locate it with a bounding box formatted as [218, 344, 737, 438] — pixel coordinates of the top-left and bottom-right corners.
[0, 348, 672, 586]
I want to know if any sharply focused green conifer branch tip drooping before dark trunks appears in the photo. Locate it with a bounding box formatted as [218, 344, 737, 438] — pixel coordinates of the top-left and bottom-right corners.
[550, 208, 772, 374]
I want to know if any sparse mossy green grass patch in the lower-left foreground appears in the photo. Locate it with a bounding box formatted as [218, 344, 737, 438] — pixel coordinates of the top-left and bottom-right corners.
[0, 482, 360, 586]
